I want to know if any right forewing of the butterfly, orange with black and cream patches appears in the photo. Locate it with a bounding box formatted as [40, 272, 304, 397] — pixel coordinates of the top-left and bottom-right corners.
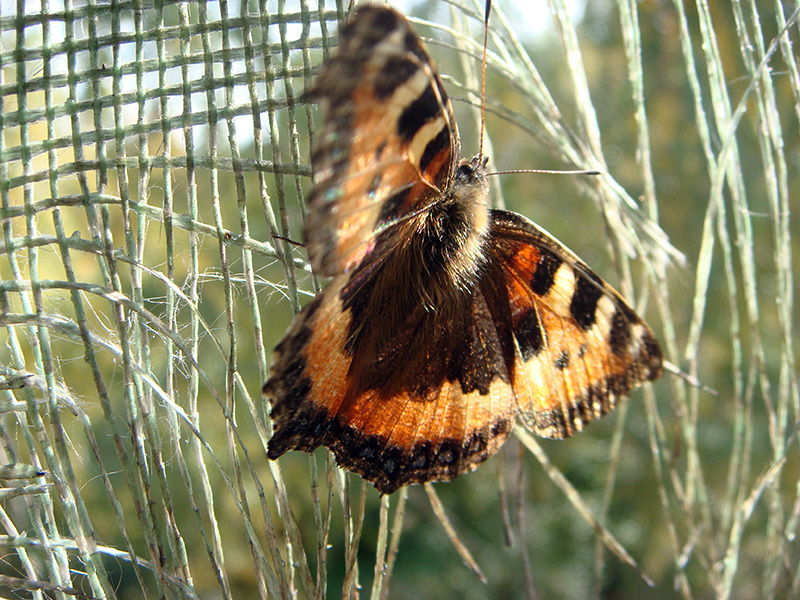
[487, 210, 662, 438]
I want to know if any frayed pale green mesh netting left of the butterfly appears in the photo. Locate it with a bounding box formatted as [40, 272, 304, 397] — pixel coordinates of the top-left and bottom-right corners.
[0, 0, 330, 597]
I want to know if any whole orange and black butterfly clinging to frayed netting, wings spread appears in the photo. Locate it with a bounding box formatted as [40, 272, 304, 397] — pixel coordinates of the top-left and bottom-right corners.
[263, 5, 662, 494]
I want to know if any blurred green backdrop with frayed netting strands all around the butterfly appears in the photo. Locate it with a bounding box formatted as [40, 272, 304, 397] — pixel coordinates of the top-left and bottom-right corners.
[0, 0, 800, 599]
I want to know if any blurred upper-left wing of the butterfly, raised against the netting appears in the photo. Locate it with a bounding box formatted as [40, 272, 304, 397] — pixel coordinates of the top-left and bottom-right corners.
[305, 6, 460, 276]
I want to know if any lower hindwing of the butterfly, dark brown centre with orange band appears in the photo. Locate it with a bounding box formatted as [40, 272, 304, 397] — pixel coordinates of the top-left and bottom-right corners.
[264, 270, 516, 493]
